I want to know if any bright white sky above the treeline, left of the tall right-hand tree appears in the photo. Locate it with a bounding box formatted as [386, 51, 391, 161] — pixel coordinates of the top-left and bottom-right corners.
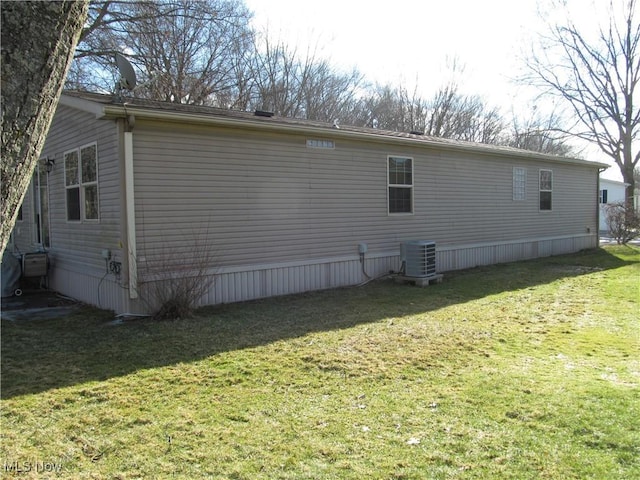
[245, 0, 617, 178]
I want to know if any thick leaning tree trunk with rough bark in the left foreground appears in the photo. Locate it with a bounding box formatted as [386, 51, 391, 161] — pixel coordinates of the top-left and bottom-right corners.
[0, 0, 88, 256]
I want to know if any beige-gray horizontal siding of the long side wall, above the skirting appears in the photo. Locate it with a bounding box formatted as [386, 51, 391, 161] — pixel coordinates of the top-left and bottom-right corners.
[134, 121, 597, 276]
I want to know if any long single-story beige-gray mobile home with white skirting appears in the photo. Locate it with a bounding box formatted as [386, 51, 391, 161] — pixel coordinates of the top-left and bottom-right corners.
[13, 92, 606, 313]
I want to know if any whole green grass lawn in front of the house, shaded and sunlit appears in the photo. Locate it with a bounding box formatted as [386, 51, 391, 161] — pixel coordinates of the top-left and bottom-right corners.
[0, 246, 640, 480]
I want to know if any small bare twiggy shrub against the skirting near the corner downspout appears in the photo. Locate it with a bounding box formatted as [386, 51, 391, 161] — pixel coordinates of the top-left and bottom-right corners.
[140, 233, 217, 320]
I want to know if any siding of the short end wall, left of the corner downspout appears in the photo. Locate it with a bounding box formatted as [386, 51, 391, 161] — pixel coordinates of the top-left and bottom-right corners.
[42, 105, 127, 311]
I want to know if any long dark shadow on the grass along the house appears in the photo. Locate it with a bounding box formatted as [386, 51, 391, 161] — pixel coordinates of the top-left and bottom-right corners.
[1, 247, 638, 399]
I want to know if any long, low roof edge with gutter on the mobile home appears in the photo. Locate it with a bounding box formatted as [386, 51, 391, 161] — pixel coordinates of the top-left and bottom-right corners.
[60, 91, 609, 169]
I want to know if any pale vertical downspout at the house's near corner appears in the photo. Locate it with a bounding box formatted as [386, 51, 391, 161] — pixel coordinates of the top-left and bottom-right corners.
[124, 115, 138, 299]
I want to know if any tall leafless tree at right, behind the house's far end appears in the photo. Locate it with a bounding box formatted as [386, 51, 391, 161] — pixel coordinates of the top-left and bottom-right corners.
[525, 0, 640, 210]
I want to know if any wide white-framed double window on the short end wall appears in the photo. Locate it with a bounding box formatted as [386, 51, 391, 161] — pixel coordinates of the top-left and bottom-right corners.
[64, 143, 99, 221]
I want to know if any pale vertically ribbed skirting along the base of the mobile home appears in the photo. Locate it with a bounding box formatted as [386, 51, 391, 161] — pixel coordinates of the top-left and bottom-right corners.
[50, 234, 598, 313]
